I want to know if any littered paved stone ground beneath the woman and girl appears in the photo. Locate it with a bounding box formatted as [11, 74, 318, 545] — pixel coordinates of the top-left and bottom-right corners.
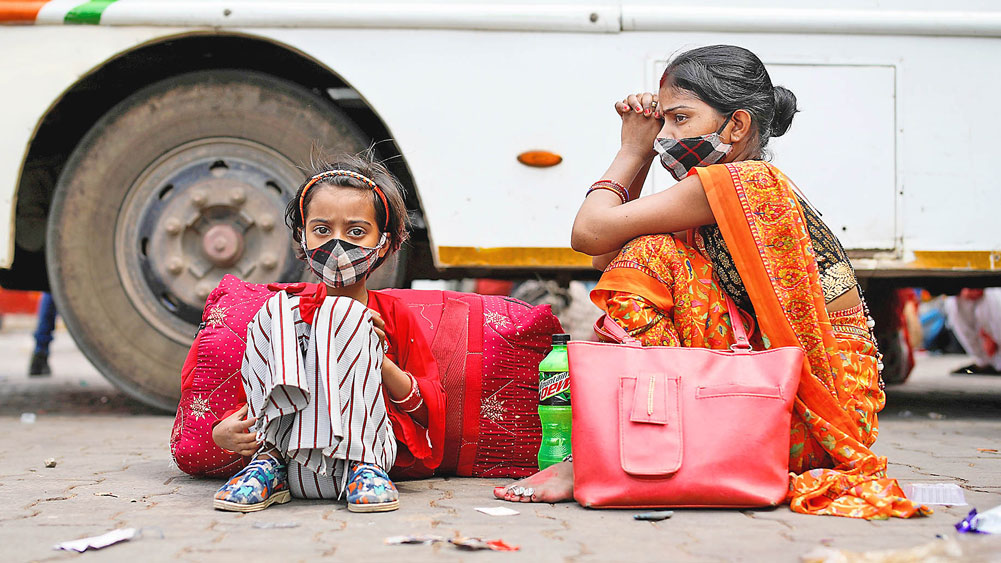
[0, 318, 1001, 562]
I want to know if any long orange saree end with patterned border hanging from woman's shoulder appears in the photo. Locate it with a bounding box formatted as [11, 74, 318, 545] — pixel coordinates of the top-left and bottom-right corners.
[696, 160, 931, 519]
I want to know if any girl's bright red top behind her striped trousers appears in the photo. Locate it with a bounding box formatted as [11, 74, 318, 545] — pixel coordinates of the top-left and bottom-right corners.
[205, 284, 445, 479]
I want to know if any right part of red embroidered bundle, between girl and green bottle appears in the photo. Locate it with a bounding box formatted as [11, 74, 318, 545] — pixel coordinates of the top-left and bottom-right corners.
[380, 290, 563, 477]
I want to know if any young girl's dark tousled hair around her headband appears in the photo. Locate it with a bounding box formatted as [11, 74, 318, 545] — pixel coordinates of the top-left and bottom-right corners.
[285, 149, 409, 261]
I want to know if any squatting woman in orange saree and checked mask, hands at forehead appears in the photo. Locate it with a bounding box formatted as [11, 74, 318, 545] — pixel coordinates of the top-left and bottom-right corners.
[494, 45, 926, 518]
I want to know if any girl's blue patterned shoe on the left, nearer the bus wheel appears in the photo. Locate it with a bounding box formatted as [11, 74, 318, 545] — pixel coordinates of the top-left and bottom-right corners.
[212, 458, 291, 512]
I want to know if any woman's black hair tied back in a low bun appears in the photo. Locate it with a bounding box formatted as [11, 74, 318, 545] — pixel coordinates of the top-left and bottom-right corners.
[661, 45, 799, 152]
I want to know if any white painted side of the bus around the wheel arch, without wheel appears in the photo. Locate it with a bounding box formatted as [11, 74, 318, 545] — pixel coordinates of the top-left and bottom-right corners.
[0, 0, 1001, 269]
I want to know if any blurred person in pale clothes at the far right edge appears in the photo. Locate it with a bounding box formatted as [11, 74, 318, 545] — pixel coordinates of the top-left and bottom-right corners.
[945, 288, 1001, 376]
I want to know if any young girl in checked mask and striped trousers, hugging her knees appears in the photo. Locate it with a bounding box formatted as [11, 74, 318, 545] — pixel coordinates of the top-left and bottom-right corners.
[212, 151, 444, 512]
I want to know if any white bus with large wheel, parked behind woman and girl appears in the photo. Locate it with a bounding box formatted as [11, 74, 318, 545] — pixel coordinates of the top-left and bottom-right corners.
[0, 0, 1001, 409]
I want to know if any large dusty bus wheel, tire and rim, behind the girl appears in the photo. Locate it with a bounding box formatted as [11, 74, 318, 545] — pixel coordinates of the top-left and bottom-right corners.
[46, 70, 369, 411]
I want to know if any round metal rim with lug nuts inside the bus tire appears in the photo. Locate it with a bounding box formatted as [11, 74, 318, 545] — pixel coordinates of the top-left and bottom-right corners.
[116, 139, 302, 338]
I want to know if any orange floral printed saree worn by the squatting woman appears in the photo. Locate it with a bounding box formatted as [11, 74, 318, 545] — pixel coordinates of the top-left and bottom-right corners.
[592, 160, 930, 519]
